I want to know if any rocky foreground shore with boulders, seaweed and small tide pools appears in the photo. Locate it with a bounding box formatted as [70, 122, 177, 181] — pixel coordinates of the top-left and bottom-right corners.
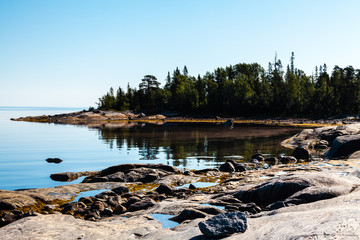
[0, 124, 360, 240]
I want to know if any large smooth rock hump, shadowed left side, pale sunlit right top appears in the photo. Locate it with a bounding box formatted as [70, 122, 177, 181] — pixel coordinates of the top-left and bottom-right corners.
[234, 173, 359, 209]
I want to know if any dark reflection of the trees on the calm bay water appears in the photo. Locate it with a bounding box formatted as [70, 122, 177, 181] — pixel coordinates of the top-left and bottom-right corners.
[96, 122, 300, 166]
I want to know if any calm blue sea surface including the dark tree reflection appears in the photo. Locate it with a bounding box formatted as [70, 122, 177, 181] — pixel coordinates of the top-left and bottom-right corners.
[0, 107, 299, 190]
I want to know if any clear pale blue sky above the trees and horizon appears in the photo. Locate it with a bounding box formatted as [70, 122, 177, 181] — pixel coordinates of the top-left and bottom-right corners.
[0, 0, 360, 108]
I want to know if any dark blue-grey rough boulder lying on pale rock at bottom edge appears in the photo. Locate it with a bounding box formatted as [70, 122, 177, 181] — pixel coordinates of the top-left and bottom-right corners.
[199, 212, 247, 238]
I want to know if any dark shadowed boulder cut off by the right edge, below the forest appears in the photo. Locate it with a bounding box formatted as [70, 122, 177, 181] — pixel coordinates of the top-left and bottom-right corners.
[325, 134, 360, 159]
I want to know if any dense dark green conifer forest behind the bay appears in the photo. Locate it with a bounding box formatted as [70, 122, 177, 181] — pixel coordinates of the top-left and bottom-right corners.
[97, 53, 360, 117]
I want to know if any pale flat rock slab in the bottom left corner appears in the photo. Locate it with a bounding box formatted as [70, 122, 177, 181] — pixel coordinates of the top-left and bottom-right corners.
[0, 214, 161, 240]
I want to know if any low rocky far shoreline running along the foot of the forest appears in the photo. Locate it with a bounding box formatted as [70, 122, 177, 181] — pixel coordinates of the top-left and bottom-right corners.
[11, 109, 360, 127]
